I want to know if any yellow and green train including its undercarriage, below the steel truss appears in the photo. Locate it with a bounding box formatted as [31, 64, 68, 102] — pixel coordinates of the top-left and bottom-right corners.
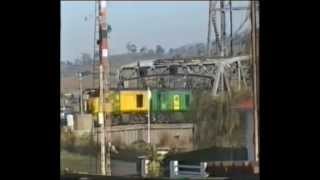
[85, 89, 192, 124]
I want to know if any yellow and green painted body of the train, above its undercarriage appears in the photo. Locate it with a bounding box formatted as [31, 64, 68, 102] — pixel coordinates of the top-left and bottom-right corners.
[87, 89, 192, 115]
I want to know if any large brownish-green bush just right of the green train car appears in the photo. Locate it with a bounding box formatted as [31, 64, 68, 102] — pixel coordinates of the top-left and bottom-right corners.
[185, 90, 251, 148]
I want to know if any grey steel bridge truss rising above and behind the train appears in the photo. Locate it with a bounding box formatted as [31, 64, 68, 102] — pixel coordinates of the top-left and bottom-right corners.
[118, 55, 251, 96]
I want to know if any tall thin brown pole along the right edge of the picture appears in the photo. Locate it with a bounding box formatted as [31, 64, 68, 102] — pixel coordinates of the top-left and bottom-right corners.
[251, 1, 259, 162]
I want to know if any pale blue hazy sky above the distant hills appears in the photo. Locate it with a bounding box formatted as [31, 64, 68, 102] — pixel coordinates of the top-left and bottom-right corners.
[61, 1, 249, 61]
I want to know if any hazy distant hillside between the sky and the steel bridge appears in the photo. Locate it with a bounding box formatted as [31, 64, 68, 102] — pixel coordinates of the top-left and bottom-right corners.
[61, 31, 254, 92]
